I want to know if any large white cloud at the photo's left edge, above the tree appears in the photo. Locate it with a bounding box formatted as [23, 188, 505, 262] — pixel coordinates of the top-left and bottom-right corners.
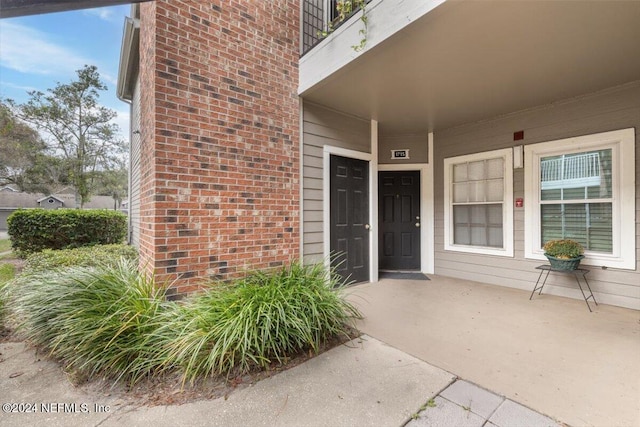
[0, 21, 91, 75]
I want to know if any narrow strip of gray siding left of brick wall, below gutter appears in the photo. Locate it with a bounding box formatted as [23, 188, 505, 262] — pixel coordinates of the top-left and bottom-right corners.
[129, 78, 142, 248]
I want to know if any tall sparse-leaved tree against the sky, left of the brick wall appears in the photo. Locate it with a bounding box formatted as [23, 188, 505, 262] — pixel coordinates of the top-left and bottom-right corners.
[10, 65, 126, 207]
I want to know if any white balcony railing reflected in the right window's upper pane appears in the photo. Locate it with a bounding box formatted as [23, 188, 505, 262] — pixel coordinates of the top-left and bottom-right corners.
[540, 153, 600, 190]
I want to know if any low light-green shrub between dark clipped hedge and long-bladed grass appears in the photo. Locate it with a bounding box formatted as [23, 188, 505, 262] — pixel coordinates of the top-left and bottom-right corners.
[24, 245, 138, 274]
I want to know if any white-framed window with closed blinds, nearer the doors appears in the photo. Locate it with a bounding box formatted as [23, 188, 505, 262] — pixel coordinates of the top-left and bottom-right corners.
[444, 149, 513, 256]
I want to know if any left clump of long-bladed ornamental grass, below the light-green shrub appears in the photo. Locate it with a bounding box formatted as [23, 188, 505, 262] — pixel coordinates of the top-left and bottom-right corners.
[11, 260, 174, 382]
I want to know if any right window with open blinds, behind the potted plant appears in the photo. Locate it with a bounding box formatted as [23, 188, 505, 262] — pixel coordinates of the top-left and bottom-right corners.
[525, 129, 635, 269]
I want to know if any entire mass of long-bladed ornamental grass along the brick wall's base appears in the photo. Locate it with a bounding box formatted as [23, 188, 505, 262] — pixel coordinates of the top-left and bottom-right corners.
[9, 259, 360, 383]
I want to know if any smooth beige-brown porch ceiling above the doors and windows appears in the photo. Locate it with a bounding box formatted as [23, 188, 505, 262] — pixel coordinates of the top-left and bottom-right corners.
[302, 1, 640, 133]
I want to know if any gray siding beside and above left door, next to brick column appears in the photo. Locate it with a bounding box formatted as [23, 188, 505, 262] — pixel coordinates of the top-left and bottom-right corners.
[302, 103, 371, 262]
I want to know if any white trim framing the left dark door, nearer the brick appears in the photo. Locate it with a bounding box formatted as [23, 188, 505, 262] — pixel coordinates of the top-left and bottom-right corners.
[322, 147, 377, 281]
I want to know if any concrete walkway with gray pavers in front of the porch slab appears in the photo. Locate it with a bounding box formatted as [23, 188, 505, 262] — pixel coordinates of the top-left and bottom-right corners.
[0, 336, 558, 427]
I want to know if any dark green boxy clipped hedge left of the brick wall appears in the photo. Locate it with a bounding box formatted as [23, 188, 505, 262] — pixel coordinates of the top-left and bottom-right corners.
[7, 209, 127, 256]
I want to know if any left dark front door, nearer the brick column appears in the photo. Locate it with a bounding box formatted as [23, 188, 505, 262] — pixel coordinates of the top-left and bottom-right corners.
[330, 155, 369, 282]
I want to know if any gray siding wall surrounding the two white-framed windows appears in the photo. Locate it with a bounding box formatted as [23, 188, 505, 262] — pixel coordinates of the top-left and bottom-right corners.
[434, 82, 640, 309]
